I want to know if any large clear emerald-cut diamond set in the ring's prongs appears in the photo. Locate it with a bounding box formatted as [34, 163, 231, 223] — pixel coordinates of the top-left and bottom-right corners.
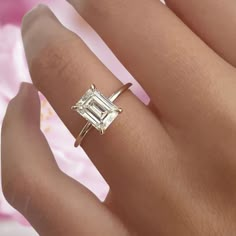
[72, 85, 122, 134]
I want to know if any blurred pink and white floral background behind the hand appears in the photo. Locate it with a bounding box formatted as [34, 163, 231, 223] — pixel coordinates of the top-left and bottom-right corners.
[0, 0, 148, 236]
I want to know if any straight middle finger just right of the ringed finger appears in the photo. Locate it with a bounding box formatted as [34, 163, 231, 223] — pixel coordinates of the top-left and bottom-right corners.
[66, 0, 235, 134]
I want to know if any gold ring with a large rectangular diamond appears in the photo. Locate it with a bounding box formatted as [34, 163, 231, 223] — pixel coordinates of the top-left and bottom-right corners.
[71, 83, 132, 147]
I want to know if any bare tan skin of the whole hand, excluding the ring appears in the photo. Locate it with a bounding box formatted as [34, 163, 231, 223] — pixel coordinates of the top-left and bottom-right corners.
[1, 0, 236, 236]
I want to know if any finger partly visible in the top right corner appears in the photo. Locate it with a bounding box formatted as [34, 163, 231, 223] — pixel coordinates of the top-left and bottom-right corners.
[166, 0, 236, 66]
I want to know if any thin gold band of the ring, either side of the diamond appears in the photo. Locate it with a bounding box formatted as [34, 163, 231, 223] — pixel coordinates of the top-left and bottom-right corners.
[74, 83, 132, 147]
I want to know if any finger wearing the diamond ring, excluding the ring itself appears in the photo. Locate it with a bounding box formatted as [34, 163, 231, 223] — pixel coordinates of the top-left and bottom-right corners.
[20, 4, 171, 196]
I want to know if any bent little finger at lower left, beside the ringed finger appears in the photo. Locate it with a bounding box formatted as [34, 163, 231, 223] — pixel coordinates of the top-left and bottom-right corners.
[1, 84, 126, 236]
